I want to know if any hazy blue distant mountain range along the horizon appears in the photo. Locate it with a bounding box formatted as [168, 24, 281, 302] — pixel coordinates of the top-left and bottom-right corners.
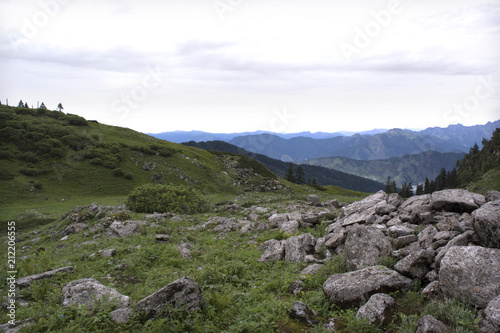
[152, 120, 500, 163]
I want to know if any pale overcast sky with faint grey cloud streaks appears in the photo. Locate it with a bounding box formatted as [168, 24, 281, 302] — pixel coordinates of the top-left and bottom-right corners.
[0, 0, 500, 133]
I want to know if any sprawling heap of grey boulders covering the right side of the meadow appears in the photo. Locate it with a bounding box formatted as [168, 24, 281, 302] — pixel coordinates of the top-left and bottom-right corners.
[259, 189, 500, 332]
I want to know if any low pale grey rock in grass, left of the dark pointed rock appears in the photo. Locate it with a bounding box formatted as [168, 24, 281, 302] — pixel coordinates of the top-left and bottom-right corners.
[62, 278, 130, 308]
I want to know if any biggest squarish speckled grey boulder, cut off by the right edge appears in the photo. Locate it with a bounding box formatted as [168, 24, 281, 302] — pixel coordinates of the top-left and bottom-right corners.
[439, 246, 500, 308]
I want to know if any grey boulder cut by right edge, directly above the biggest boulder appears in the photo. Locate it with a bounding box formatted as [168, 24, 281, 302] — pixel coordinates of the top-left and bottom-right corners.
[471, 200, 500, 248]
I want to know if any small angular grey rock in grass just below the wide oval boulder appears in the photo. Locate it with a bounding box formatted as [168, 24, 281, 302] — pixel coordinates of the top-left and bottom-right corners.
[356, 294, 396, 327]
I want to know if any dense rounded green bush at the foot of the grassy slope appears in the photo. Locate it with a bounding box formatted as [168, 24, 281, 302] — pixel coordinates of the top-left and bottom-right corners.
[127, 184, 209, 214]
